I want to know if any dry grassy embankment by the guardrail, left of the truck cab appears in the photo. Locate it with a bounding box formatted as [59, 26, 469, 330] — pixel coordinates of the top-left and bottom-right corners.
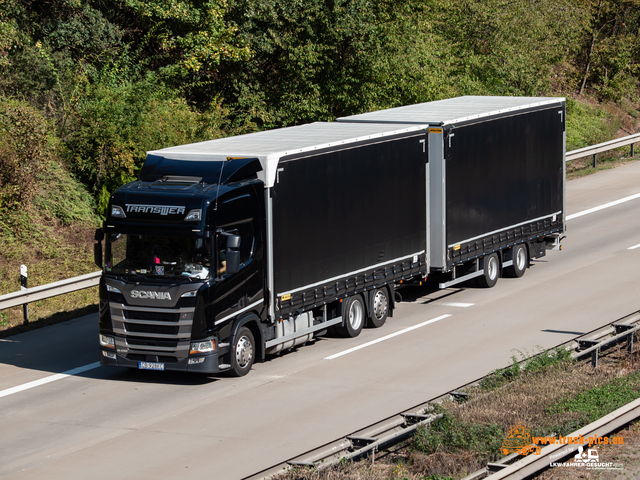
[0, 158, 99, 338]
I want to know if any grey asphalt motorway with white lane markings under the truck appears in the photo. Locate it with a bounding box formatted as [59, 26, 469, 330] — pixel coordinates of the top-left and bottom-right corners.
[0, 162, 640, 480]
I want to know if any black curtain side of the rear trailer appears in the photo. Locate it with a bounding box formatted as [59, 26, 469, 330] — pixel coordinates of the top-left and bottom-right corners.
[445, 104, 565, 264]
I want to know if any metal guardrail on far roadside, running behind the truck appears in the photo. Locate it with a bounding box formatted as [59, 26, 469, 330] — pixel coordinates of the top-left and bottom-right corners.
[0, 133, 640, 316]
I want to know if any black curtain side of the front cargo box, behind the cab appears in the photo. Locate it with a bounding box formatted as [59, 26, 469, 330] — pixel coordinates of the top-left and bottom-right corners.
[272, 132, 427, 316]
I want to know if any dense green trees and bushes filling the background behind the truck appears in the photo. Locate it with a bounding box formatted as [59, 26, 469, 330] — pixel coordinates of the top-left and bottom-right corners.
[0, 0, 640, 224]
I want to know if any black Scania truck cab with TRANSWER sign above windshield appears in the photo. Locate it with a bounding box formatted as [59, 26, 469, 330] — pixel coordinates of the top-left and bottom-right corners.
[96, 155, 265, 375]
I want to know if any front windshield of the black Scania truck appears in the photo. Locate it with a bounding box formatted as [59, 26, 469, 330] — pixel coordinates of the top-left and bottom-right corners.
[104, 233, 211, 279]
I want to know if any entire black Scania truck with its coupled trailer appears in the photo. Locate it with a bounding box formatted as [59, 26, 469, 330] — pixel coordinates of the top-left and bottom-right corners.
[96, 97, 565, 375]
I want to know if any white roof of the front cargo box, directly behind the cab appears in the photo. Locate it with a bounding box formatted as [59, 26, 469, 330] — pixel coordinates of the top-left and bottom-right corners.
[147, 122, 424, 187]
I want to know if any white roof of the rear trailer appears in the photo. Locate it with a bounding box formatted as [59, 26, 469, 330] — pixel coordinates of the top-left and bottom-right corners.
[337, 96, 565, 125]
